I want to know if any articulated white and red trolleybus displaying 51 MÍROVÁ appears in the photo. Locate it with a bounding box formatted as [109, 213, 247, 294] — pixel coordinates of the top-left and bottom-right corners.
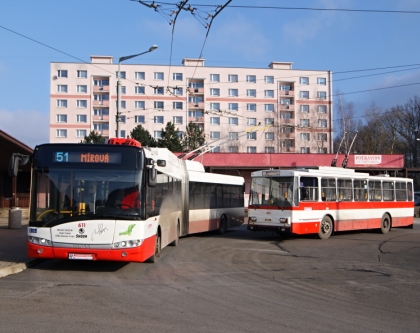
[9, 139, 244, 262]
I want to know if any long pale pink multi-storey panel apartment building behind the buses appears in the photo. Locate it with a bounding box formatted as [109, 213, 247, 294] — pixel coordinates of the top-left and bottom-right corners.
[50, 56, 333, 153]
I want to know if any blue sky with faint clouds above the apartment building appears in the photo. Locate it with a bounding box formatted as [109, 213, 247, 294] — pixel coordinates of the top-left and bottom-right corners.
[0, 0, 420, 147]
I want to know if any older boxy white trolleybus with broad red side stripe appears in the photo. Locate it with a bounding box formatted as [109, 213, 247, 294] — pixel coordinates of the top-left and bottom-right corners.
[247, 167, 414, 239]
